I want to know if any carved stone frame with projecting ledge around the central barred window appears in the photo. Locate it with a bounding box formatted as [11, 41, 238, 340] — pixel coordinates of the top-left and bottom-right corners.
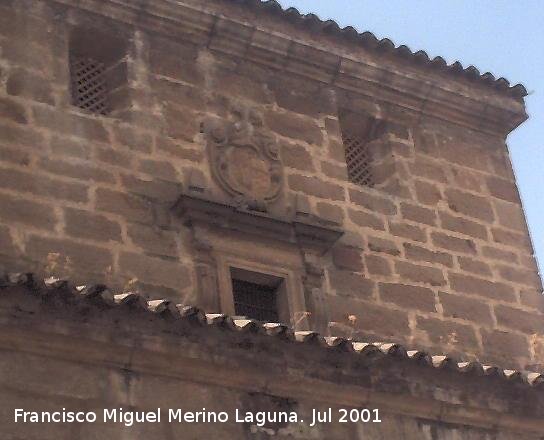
[173, 193, 343, 330]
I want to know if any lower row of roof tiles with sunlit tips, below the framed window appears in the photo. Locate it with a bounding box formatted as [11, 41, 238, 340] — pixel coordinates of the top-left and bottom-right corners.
[0, 273, 544, 387]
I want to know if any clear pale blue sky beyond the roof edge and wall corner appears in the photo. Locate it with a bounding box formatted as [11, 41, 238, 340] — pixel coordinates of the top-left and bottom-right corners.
[278, 0, 544, 274]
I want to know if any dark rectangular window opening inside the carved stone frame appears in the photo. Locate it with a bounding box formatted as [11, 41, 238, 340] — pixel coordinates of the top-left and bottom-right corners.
[231, 268, 283, 322]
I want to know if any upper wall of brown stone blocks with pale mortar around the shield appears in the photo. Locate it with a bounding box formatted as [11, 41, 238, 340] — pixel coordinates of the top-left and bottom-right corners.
[0, 0, 544, 369]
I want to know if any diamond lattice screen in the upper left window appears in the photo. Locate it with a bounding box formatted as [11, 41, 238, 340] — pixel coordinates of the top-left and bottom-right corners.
[70, 58, 108, 115]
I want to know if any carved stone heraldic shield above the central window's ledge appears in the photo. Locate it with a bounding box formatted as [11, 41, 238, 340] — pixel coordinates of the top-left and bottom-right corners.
[204, 107, 283, 209]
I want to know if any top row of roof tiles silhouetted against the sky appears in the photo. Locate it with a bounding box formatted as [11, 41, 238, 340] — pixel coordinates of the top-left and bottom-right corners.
[231, 0, 527, 98]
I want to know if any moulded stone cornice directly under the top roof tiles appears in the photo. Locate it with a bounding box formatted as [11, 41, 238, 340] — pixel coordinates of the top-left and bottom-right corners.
[52, 0, 527, 137]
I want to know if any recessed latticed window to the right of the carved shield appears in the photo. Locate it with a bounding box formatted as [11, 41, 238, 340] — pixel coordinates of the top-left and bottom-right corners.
[339, 112, 380, 187]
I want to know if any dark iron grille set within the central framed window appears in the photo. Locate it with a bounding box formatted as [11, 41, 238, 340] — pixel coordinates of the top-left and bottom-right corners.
[232, 278, 279, 322]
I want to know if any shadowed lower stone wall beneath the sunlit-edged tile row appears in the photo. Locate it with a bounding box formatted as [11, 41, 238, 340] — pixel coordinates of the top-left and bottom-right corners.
[0, 281, 544, 440]
